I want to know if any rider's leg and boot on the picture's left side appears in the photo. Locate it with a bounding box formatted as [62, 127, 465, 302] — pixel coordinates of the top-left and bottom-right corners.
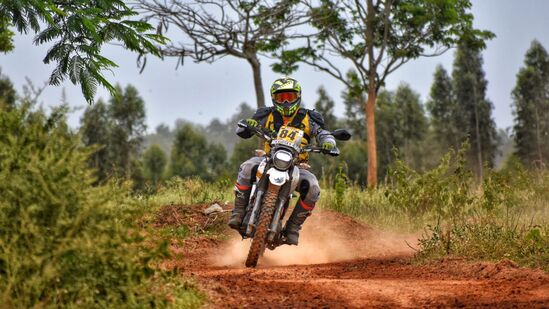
[228, 157, 262, 230]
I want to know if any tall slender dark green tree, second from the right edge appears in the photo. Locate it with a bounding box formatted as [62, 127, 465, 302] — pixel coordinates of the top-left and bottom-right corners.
[452, 43, 497, 179]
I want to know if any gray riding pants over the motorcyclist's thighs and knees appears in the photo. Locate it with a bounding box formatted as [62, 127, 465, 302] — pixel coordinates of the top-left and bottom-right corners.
[237, 157, 320, 207]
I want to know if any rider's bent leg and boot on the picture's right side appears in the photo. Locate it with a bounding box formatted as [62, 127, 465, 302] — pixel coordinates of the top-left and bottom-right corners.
[284, 169, 320, 245]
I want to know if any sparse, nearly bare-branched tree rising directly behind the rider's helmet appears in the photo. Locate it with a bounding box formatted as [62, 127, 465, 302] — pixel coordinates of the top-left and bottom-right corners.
[138, 0, 307, 108]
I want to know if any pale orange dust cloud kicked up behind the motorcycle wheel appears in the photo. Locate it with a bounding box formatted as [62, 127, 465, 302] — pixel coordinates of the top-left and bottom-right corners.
[210, 210, 418, 267]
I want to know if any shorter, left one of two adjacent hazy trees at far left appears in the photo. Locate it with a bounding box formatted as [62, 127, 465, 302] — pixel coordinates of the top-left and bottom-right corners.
[80, 100, 112, 182]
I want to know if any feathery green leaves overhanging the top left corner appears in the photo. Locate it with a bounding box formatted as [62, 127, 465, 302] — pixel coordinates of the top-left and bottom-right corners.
[0, 0, 165, 103]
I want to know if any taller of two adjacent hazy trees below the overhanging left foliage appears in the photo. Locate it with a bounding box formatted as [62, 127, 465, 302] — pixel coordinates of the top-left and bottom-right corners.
[109, 85, 147, 178]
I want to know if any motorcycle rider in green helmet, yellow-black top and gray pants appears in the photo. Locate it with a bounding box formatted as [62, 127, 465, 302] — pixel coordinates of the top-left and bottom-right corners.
[229, 77, 336, 245]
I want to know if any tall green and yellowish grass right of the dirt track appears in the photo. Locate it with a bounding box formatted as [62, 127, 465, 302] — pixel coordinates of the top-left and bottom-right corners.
[320, 154, 549, 271]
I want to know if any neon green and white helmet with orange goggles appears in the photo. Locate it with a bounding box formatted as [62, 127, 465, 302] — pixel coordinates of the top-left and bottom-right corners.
[271, 77, 301, 117]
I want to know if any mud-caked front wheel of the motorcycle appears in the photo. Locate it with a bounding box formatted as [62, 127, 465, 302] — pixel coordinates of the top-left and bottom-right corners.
[246, 185, 280, 267]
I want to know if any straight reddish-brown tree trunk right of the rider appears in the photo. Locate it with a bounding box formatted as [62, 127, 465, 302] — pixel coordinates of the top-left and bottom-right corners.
[364, 82, 377, 188]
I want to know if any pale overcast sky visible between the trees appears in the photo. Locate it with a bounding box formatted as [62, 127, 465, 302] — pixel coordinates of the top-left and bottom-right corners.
[0, 0, 549, 131]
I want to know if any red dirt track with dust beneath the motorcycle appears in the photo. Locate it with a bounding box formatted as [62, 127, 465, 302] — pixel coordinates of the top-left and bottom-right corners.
[158, 205, 549, 308]
